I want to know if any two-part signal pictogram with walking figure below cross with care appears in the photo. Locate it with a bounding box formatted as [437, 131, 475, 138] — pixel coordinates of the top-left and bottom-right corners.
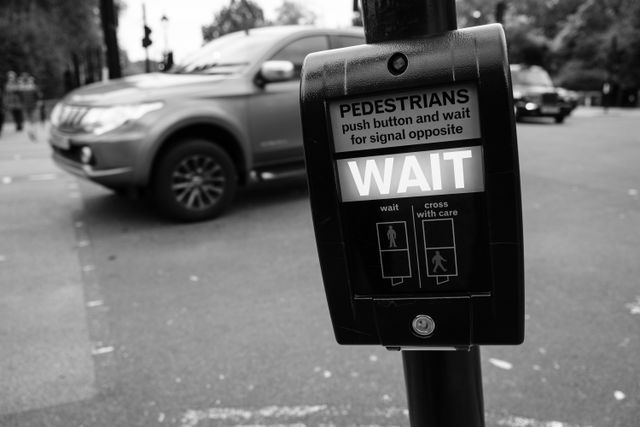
[422, 218, 458, 285]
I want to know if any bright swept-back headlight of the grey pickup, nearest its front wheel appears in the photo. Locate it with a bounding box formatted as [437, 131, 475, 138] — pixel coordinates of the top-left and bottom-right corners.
[79, 102, 163, 135]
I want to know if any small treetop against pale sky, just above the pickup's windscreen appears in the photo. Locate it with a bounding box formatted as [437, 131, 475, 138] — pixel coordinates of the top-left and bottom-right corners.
[202, 0, 265, 42]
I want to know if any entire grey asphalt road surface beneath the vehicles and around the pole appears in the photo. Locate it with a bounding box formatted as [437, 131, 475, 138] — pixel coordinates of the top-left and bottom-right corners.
[0, 110, 640, 427]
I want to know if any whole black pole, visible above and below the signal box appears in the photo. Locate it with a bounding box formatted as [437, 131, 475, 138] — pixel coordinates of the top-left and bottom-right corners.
[362, 0, 485, 427]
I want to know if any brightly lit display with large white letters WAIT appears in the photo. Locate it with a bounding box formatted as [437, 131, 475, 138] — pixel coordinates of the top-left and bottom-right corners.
[337, 146, 484, 202]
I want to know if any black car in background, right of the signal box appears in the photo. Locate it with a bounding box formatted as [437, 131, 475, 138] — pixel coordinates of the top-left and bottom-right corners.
[511, 64, 570, 123]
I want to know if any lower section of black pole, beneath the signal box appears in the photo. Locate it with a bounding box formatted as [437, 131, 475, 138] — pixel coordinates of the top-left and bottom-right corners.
[402, 346, 485, 427]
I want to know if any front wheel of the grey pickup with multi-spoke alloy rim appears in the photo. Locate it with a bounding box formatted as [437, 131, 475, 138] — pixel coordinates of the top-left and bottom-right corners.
[151, 139, 238, 221]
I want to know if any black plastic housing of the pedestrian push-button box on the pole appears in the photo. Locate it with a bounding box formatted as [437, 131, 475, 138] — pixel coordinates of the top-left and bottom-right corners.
[301, 24, 524, 348]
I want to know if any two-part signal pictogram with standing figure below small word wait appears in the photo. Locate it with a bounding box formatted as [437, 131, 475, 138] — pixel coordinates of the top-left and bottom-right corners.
[376, 221, 411, 286]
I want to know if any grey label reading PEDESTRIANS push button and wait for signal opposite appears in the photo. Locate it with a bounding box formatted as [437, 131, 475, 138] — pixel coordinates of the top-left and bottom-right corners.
[329, 83, 481, 153]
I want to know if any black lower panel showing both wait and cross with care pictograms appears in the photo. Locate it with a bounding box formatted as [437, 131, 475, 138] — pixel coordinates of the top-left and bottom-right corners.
[342, 193, 490, 295]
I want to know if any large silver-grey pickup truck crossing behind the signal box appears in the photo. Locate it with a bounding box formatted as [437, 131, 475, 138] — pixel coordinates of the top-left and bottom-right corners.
[49, 26, 364, 221]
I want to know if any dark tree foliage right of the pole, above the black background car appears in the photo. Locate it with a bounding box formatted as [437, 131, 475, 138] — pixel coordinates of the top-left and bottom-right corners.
[456, 0, 640, 90]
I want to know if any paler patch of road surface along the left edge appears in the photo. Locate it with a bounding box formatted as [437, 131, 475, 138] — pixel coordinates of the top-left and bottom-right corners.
[0, 123, 95, 415]
